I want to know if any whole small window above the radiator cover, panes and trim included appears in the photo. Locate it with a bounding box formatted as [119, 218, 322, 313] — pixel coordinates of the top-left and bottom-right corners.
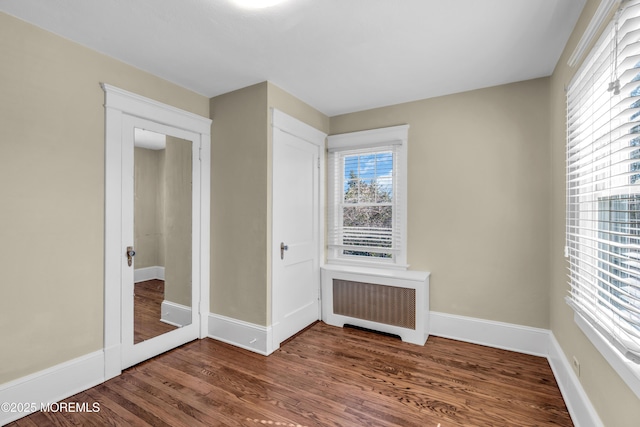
[328, 125, 409, 268]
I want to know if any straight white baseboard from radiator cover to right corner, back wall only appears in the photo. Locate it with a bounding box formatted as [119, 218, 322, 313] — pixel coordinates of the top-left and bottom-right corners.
[429, 311, 550, 357]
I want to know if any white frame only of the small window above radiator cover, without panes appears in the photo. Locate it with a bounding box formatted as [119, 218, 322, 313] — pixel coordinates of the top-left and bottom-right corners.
[327, 125, 409, 270]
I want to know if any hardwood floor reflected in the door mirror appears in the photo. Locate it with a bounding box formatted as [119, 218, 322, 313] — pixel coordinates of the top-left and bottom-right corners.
[133, 279, 176, 344]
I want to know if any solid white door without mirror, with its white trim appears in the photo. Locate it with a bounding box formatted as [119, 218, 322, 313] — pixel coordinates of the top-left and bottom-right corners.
[272, 110, 325, 349]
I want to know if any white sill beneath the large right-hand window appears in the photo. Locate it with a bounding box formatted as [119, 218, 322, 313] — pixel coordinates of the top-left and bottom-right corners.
[573, 312, 640, 398]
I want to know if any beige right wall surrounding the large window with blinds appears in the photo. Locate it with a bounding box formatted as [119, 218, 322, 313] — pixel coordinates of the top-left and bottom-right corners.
[549, 0, 640, 427]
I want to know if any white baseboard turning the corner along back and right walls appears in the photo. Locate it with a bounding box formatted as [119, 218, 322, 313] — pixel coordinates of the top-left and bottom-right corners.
[430, 312, 603, 427]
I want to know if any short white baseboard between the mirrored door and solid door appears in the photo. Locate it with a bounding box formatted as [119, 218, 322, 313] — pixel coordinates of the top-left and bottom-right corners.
[209, 313, 275, 356]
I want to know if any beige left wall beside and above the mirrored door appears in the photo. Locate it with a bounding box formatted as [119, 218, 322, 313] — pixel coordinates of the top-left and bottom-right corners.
[0, 13, 209, 383]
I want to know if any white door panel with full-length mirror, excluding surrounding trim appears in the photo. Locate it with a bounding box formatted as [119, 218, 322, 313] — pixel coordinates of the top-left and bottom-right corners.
[121, 116, 200, 369]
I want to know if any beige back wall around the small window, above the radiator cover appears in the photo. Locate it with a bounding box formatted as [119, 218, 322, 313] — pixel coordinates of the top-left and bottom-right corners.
[331, 79, 550, 328]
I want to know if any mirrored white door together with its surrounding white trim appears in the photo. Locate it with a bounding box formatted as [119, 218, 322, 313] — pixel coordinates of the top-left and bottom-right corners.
[102, 84, 211, 379]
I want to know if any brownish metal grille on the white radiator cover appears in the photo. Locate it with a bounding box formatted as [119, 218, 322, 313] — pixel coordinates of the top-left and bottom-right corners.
[333, 279, 416, 329]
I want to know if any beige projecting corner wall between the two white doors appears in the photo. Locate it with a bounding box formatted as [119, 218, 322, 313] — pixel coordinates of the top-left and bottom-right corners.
[210, 82, 329, 326]
